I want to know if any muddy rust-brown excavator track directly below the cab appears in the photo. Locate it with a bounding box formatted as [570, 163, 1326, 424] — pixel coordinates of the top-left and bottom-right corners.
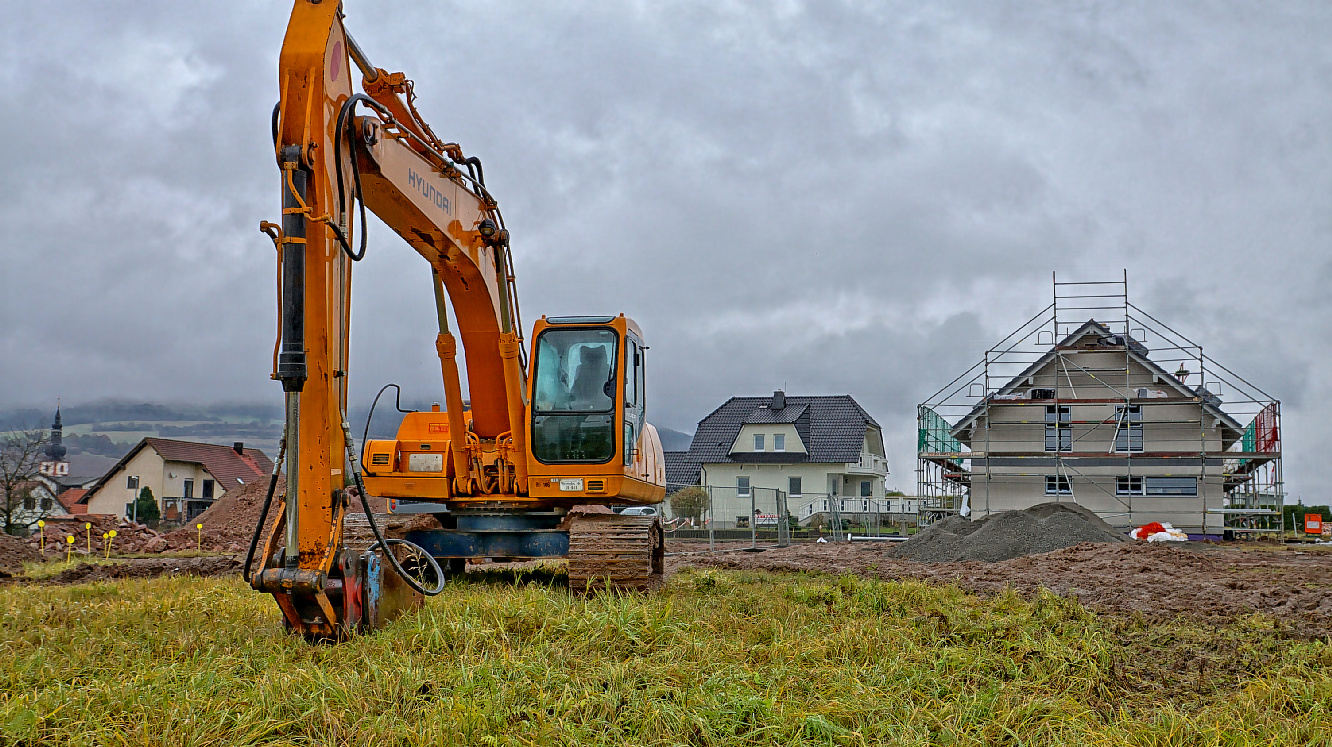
[569, 514, 666, 593]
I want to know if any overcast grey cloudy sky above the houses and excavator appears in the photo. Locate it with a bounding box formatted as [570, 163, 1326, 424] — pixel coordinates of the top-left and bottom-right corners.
[0, 0, 1332, 502]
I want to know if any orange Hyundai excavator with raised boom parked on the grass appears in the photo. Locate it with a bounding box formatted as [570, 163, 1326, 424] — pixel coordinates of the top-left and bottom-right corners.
[245, 0, 665, 640]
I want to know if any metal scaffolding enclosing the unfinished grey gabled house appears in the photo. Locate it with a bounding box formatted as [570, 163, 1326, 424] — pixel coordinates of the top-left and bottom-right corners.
[916, 272, 1284, 538]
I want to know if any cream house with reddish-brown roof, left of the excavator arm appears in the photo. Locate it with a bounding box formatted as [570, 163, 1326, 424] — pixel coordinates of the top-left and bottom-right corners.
[79, 438, 273, 522]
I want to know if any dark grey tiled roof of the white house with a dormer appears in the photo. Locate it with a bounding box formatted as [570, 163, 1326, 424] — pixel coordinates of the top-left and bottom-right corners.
[676, 394, 879, 471]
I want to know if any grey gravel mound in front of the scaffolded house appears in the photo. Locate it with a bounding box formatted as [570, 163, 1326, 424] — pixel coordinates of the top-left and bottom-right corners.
[888, 503, 1130, 563]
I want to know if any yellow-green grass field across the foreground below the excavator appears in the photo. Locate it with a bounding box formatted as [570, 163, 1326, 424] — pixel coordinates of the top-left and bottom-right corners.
[0, 571, 1332, 746]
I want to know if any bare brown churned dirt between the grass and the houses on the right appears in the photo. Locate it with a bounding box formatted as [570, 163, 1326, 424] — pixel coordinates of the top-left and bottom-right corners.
[667, 542, 1332, 638]
